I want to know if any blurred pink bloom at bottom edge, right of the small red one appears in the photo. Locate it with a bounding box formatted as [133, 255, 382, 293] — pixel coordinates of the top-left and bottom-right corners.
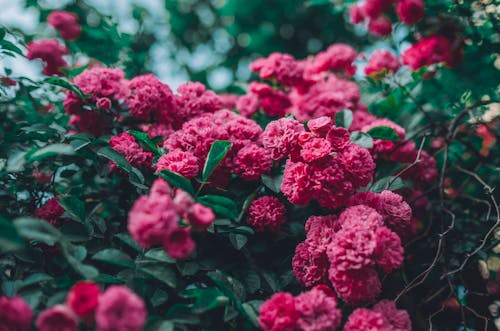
[96, 286, 147, 331]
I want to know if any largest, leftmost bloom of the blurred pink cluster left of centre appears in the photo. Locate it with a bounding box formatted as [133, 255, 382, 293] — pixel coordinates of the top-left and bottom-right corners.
[128, 179, 179, 248]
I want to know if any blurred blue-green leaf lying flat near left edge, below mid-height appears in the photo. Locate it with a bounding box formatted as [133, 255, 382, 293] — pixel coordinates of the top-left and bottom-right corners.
[14, 217, 62, 246]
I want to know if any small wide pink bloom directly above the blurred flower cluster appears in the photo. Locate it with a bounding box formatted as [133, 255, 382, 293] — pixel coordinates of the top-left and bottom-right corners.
[156, 149, 199, 179]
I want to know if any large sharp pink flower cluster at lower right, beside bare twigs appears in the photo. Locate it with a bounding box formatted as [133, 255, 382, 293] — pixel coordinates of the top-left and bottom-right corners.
[292, 205, 411, 305]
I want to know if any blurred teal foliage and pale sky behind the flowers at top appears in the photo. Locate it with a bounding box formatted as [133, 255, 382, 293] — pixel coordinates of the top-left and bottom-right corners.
[0, 0, 382, 92]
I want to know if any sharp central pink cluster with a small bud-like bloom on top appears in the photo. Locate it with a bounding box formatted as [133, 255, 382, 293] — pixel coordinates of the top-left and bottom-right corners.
[262, 116, 375, 208]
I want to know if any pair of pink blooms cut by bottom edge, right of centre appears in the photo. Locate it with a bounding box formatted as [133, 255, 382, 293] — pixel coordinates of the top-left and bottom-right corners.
[259, 285, 342, 331]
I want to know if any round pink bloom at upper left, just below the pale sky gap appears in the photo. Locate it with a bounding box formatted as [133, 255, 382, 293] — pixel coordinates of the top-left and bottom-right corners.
[125, 74, 176, 124]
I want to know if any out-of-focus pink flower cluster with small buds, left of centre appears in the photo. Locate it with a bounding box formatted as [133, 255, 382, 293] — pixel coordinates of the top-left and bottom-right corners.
[128, 179, 215, 259]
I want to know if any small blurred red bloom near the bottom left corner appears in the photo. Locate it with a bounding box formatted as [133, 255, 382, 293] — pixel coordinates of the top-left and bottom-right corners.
[66, 281, 100, 318]
